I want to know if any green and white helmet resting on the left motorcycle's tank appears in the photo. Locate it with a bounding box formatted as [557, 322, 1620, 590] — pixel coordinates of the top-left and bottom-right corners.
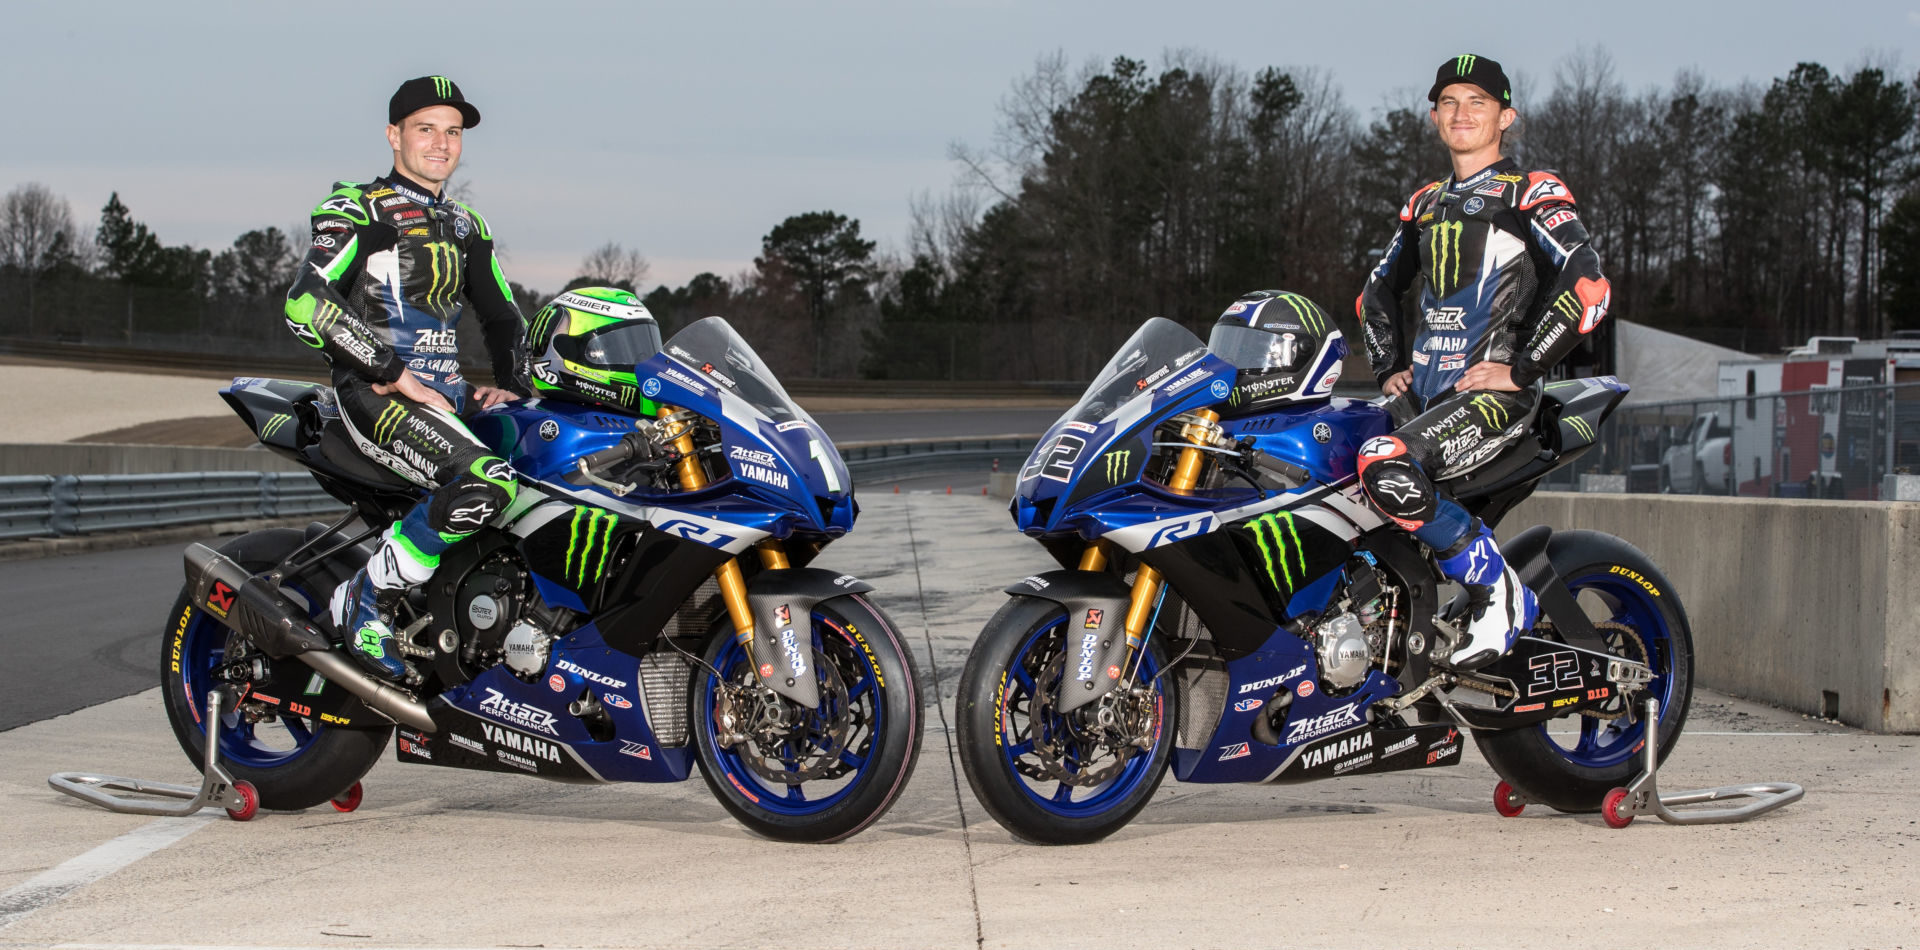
[526, 288, 660, 415]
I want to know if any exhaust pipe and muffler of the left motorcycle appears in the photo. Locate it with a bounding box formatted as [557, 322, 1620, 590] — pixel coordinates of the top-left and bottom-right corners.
[186, 545, 436, 733]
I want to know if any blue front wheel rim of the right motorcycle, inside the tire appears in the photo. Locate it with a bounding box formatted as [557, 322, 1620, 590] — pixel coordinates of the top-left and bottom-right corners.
[995, 618, 1165, 818]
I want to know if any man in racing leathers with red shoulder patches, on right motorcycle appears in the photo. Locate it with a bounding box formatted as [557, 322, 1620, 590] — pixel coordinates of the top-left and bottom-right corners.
[1354, 56, 1611, 670]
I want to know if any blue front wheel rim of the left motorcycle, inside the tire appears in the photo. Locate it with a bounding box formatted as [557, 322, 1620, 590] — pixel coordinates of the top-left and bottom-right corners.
[697, 612, 887, 818]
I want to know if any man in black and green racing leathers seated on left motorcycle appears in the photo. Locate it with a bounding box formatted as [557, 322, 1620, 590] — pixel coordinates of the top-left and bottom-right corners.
[286, 77, 530, 681]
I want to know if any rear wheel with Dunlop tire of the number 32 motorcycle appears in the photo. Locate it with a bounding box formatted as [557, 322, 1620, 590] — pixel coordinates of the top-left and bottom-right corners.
[1475, 532, 1693, 812]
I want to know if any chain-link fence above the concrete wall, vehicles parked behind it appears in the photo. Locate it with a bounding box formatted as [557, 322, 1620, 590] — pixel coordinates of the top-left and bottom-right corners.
[1544, 382, 1920, 501]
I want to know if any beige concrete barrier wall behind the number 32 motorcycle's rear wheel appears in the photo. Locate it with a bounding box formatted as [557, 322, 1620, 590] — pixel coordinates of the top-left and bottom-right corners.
[1498, 491, 1920, 733]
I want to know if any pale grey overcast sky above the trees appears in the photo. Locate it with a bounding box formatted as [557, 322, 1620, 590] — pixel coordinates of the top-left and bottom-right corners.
[11, 0, 1920, 292]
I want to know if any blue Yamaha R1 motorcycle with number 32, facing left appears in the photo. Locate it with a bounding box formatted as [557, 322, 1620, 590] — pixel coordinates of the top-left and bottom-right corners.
[958, 319, 1692, 844]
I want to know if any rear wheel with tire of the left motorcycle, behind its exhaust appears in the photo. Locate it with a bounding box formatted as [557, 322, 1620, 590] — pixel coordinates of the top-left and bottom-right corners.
[159, 528, 394, 810]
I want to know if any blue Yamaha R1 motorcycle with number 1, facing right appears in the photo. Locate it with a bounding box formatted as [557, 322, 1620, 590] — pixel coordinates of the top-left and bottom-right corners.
[161, 317, 920, 841]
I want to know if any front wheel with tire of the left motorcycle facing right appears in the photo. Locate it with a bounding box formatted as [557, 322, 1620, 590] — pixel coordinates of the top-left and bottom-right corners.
[689, 595, 920, 843]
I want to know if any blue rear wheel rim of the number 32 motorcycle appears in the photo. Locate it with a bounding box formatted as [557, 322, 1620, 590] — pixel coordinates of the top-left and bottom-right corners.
[1538, 574, 1674, 770]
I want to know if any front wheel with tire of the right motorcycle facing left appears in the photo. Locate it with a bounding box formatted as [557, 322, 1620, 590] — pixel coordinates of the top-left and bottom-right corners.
[956, 597, 1181, 844]
